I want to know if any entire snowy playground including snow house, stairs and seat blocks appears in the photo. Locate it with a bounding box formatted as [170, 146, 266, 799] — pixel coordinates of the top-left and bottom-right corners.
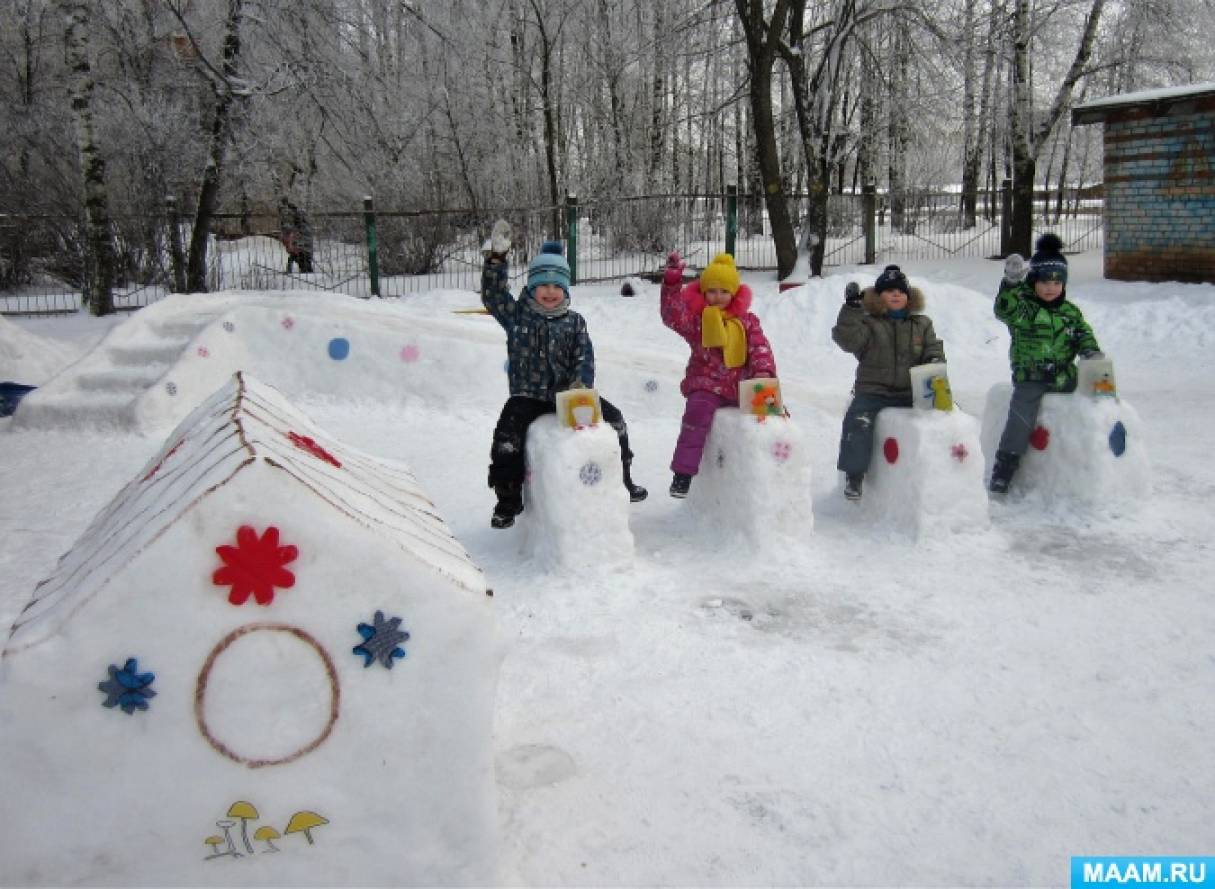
[0, 254, 1215, 887]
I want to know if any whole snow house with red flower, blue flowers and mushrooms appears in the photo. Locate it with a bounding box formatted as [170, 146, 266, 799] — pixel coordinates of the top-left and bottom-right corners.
[0, 374, 501, 885]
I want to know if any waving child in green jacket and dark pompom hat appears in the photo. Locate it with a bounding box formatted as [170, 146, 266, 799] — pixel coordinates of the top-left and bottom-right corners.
[988, 234, 1104, 494]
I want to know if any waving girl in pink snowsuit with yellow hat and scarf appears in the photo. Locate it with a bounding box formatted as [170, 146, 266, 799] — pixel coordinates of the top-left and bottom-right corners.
[661, 251, 776, 498]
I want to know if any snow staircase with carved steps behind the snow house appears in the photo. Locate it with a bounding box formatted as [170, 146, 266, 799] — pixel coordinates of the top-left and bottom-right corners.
[13, 308, 221, 431]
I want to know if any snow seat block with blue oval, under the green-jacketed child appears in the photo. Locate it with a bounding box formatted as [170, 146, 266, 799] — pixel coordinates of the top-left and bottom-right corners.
[983, 383, 1152, 508]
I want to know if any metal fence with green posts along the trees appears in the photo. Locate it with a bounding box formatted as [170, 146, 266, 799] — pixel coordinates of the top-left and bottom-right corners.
[0, 185, 1103, 313]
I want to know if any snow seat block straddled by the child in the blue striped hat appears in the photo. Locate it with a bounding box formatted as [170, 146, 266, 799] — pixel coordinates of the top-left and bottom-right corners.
[515, 414, 633, 571]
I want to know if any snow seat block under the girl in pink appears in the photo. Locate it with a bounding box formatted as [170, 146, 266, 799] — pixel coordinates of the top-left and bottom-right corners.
[686, 407, 814, 548]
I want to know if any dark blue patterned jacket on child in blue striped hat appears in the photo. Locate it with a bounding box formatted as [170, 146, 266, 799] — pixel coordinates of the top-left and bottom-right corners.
[481, 255, 595, 401]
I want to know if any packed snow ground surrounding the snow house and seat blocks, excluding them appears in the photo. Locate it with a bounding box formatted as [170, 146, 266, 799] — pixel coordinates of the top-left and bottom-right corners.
[0, 254, 1215, 885]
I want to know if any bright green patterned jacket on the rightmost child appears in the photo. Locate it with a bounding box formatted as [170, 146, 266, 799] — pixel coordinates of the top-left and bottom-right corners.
[995, 282, 1101, 392]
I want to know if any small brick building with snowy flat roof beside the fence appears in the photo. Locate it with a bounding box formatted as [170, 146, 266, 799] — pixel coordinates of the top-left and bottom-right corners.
[1072, 84, 1215, 283]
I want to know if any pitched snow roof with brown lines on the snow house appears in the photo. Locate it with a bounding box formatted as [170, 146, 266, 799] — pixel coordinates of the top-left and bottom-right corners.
[5, 373, 486, 653]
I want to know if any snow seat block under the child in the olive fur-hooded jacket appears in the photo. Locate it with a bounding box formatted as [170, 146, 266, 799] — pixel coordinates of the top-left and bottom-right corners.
[855, 408, 989, 537]
